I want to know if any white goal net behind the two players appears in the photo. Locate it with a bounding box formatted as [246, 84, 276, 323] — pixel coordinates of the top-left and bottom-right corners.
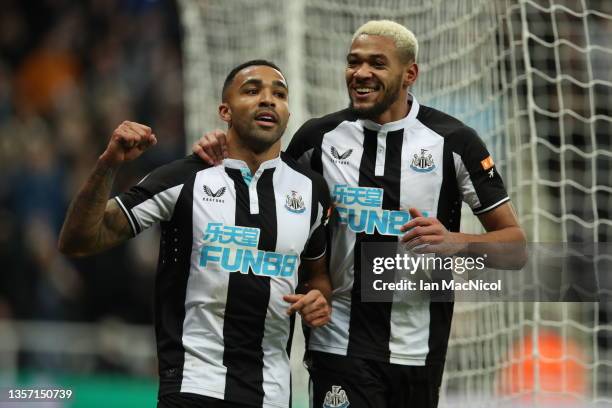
[178, 0, 612, 407]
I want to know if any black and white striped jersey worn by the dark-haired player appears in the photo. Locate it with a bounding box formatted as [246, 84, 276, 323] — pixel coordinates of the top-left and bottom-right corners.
[116, 153, 330, 407]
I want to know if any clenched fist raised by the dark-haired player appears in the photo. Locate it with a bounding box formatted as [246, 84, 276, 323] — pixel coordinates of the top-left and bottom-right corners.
[100, 121, 157, 165]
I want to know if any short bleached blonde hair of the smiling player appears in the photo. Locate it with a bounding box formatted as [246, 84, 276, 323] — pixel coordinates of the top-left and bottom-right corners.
[351, 20, 419, 63]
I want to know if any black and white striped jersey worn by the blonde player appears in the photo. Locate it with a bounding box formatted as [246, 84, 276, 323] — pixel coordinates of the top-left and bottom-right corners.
[287, 98, 509, 365]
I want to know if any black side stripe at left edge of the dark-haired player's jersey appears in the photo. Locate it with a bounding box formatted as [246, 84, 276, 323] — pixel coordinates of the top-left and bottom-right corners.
[155, 174, 195, 395]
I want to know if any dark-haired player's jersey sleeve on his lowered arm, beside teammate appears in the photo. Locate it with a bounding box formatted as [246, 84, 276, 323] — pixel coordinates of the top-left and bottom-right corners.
[302, 175, 331, 261]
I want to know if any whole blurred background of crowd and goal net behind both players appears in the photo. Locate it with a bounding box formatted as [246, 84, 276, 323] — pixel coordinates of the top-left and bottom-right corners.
[0, 0, 612, 408]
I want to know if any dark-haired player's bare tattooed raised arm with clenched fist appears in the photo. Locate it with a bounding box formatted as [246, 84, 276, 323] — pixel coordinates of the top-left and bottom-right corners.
[58, 121, 157, 256]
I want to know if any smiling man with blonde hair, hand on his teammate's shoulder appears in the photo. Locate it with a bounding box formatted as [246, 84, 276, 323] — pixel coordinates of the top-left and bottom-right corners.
[194, 20, 525, 408]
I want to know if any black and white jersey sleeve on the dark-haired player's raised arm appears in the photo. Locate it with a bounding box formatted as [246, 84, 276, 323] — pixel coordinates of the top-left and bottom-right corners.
[115, 160, 192, 236]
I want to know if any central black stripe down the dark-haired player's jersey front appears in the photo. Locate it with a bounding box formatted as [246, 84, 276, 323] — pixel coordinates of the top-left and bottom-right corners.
[223, 169, 277, 406]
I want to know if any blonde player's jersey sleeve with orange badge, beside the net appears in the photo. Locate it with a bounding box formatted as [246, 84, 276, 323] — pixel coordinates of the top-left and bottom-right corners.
[453, 127, 510, 215]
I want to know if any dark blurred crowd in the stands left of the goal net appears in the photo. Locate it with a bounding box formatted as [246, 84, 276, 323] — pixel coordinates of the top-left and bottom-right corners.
[0, 0, 185, 372]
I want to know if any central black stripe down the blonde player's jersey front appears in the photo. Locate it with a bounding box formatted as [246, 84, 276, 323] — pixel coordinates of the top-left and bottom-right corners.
[347, 129, 404, 359]
